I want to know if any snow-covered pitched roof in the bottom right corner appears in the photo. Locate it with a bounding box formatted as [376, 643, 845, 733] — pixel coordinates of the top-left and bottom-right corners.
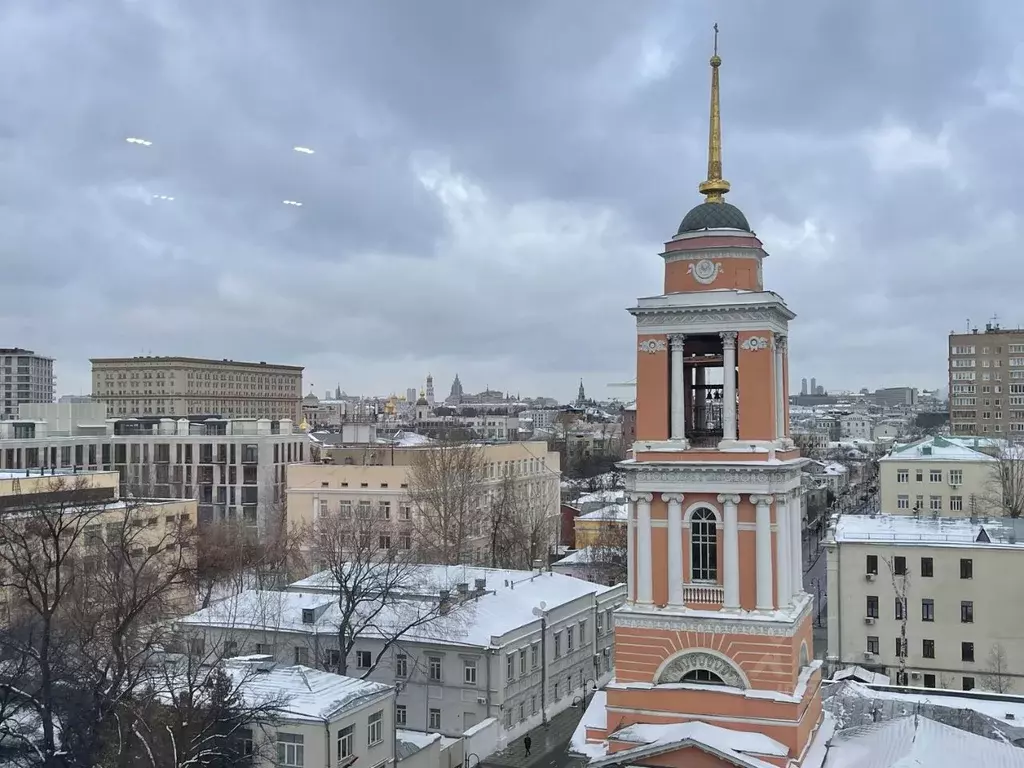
[825, 715, 1024, 768]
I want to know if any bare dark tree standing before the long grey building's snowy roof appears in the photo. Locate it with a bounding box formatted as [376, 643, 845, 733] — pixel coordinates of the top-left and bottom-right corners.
[308, 512, 452, 678]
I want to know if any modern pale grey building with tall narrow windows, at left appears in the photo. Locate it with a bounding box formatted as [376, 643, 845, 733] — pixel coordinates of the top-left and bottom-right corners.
[0, 415, 309, 528]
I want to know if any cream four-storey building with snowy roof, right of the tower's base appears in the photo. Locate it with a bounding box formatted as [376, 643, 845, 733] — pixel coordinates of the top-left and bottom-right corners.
[825, 515, 1024, 692]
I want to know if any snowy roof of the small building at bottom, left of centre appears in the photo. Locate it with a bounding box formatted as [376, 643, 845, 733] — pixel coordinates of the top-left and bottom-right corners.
[224, 657, 393, 720]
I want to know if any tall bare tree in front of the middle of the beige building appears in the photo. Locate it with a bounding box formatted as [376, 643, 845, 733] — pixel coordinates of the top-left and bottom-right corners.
[409, 441, 485, 565]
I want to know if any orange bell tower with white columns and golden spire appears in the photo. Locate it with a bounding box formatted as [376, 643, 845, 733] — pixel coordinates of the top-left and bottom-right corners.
[588, 25, 821, 765]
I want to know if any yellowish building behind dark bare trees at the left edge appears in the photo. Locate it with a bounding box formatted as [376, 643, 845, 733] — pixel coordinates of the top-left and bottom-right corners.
[0, 470, 198, 626]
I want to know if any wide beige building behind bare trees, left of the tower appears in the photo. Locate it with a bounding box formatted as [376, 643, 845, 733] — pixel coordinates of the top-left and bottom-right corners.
[287, 440, 561, 563]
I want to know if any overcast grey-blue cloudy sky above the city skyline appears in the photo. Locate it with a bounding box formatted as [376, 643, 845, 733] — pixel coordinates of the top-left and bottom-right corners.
[0, 0, 1024, 398]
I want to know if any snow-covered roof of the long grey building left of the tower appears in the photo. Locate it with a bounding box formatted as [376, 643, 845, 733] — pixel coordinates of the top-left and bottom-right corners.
[178, 571, 614, 647]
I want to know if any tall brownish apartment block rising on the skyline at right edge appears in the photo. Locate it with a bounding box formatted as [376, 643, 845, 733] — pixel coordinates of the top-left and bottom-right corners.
[949, 323, 1024, 438]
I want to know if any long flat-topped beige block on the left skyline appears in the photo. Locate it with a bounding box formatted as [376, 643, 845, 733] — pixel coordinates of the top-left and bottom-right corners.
[90, 356, 303, 423]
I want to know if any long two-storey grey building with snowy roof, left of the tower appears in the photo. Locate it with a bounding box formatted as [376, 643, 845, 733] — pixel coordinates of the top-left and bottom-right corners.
[180, 565, 625, 749]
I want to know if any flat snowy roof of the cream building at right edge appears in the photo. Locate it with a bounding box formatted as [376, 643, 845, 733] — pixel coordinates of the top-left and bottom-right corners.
[835, 515, 1024, 547]
